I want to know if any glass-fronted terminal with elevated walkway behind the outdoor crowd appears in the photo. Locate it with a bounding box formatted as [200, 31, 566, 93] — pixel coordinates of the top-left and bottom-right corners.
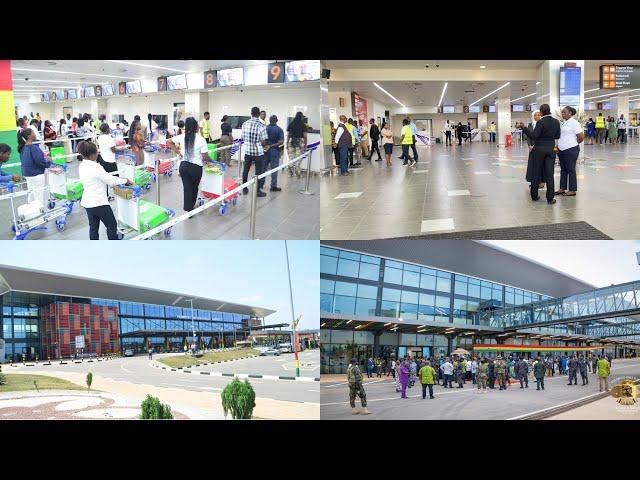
[320, 240, 640, 374]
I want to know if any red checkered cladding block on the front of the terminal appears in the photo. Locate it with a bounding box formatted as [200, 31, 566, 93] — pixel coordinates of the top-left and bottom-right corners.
[40, 302, 120, 358]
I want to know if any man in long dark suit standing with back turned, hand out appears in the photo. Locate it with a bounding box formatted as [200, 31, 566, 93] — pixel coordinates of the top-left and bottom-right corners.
[518, 103, 560, 204]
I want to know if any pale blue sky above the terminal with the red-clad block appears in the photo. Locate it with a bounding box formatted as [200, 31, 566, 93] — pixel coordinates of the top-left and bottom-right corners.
[0, 240, 320, 329]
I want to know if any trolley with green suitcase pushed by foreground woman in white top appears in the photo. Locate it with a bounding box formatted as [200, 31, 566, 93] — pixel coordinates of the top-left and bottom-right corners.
[113, 185, 176, 238]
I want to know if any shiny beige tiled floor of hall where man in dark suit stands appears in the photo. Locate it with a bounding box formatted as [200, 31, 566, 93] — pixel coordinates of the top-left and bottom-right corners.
[320, 142, 640, 240]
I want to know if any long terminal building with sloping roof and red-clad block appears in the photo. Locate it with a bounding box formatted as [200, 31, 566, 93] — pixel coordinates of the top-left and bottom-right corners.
[0, 266, 274, 361]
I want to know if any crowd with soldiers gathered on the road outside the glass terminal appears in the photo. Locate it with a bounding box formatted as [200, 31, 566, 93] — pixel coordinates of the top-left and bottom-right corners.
[347, 354, 612, 414]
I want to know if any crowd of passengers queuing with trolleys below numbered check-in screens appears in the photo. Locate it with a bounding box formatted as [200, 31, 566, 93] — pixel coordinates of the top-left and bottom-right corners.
[11, 107, 309, 240]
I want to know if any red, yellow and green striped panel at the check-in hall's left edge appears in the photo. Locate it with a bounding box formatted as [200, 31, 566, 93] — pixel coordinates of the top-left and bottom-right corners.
[0, 60, 22, 175]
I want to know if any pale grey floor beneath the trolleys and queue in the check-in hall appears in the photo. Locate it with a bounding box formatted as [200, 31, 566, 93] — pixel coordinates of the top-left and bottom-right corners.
[0, 157, 320, 240]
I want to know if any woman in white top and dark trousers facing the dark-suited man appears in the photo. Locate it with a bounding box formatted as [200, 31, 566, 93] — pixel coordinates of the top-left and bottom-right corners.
[556, 106, 584, 197]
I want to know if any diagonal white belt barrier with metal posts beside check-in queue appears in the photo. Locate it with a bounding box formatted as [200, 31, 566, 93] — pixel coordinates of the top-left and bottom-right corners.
[131, 142, 320, 240]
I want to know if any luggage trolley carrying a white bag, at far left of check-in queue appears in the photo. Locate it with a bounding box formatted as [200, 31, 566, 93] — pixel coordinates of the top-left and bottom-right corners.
[0, 182, 69, 240]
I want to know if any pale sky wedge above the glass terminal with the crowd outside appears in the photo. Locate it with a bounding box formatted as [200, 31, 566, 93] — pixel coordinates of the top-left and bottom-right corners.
[486, 240, 640, 287]
